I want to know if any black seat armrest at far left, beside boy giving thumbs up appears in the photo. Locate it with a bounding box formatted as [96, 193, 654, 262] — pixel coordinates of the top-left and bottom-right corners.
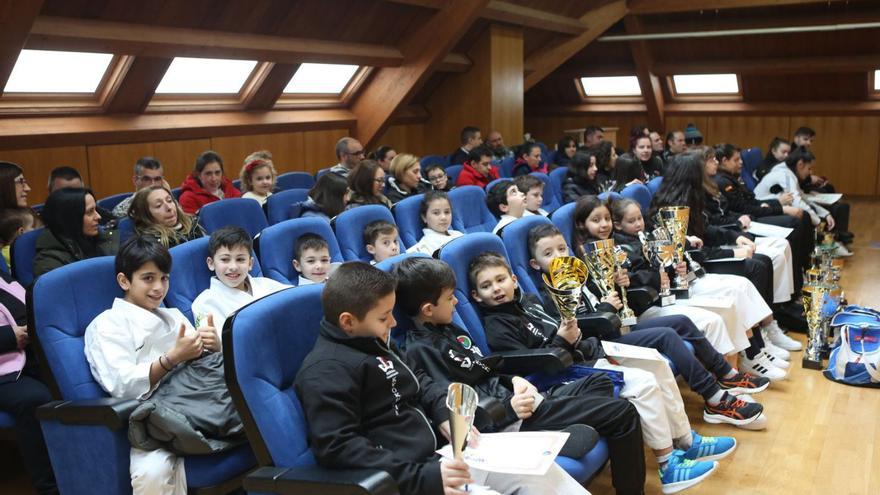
[37, 398, 140, 430]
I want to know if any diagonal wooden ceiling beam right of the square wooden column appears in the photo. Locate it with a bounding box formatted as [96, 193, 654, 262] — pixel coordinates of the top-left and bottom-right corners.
[523, 0, 628, 91]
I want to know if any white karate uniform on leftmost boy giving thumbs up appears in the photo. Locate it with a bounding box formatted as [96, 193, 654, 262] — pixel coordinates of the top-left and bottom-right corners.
[85, 298, 195, 495]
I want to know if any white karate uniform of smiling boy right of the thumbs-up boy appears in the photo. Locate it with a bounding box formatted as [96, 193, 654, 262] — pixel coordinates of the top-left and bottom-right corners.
[192, 275, 292, 336]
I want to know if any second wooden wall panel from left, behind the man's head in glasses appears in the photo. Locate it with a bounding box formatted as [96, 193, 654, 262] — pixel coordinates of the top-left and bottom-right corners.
[88, 139, 211, 198]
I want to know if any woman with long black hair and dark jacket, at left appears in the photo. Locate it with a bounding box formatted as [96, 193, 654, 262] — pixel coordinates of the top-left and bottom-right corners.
[34, 188, 119, 277]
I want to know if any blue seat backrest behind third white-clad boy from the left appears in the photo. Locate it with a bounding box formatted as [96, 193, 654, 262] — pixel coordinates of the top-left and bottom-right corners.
[260, 217, 342, 285]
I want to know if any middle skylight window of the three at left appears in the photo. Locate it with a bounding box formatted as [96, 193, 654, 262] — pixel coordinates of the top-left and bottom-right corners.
[156, 57, 257, 94]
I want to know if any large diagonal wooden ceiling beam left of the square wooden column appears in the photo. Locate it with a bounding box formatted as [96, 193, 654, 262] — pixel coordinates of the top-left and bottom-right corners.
[351, 0, 488, 148]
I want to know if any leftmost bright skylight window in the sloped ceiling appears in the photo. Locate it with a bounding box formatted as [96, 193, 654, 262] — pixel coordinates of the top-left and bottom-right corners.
[3, 50, 113, 93]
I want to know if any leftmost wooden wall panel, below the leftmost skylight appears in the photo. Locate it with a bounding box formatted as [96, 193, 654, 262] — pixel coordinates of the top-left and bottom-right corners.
[0, 146, 89, 205]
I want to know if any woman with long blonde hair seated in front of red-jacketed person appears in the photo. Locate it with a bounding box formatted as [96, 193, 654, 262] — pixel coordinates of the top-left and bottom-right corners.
[128, 186, 205, 248]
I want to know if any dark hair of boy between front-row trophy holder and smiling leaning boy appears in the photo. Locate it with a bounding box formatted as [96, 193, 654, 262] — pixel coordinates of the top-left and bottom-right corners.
[394, 258, 455, 316]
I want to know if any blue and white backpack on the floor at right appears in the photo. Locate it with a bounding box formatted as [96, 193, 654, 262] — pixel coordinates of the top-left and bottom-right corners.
[824, 306, 880, 388]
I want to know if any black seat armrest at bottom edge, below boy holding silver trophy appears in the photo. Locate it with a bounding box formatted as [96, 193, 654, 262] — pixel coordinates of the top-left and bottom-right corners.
[244, 466, 399, 495]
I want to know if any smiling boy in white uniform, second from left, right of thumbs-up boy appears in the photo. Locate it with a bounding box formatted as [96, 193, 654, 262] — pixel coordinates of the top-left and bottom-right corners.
[192, 227, 290, 332]
